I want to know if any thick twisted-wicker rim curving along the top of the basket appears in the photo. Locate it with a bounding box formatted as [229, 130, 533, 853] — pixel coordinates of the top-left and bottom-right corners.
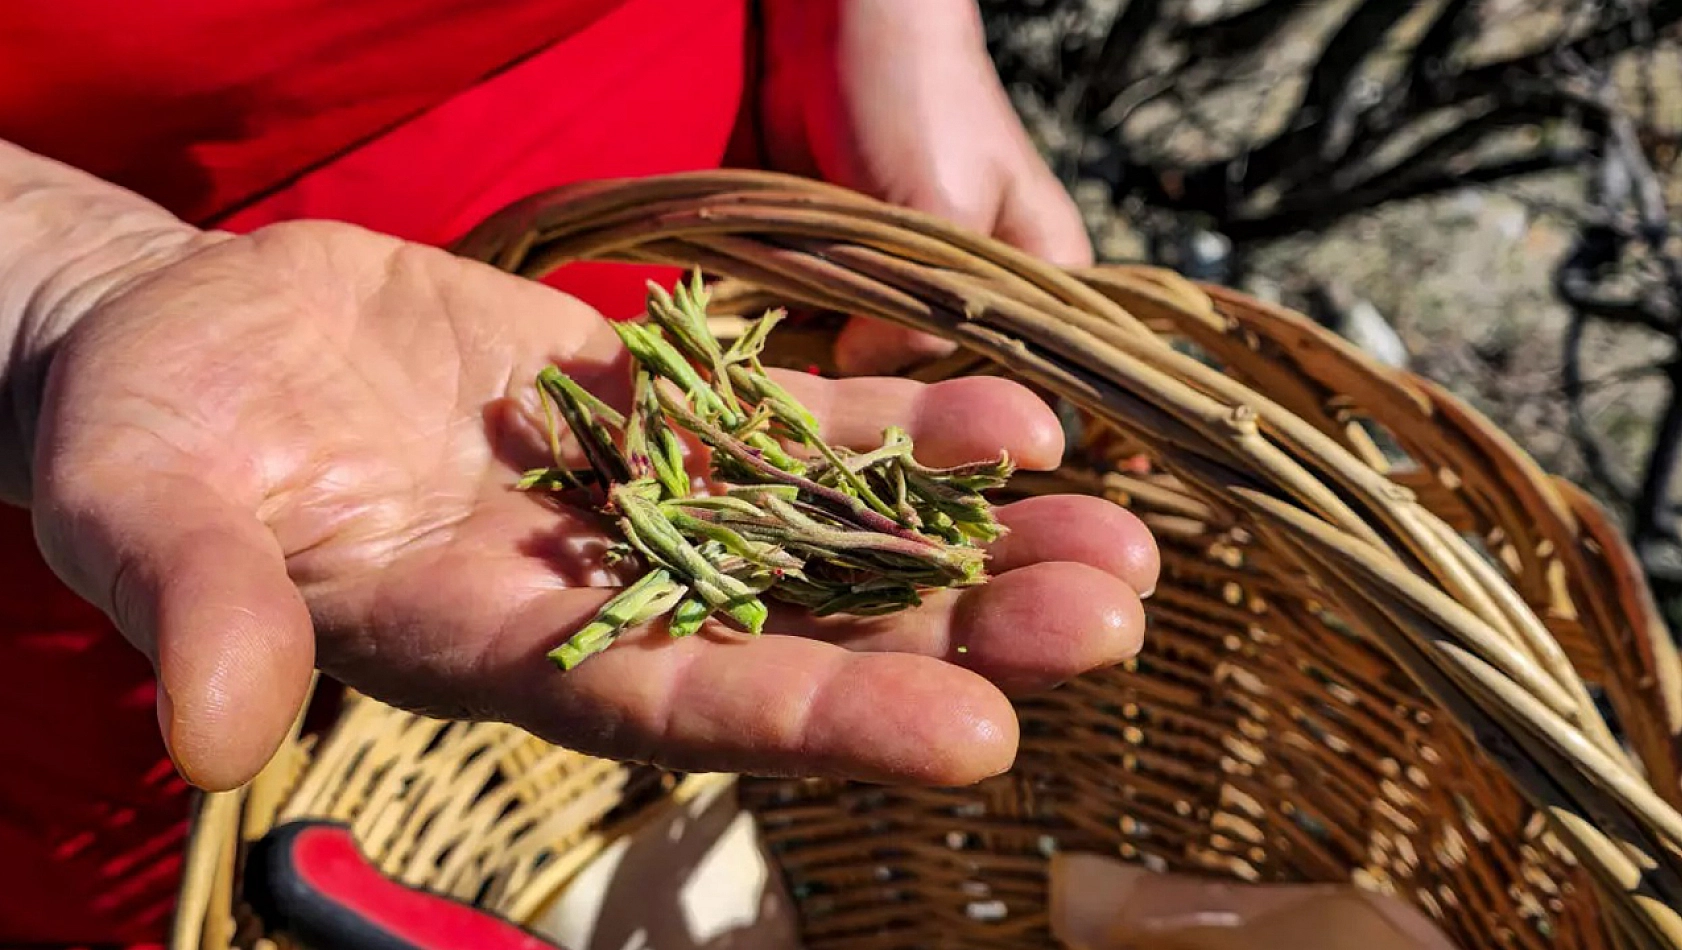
[177, 172, 1682, 950]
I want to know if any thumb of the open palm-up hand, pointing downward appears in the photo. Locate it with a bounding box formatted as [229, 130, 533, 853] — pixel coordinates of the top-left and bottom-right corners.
[34, 466, 315, 790]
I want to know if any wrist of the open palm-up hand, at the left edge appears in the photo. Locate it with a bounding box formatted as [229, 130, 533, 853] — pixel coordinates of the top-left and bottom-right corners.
[0, 141, 205, 506]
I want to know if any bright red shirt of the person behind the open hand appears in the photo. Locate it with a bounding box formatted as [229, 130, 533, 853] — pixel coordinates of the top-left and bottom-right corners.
[0, 0, 750, 947]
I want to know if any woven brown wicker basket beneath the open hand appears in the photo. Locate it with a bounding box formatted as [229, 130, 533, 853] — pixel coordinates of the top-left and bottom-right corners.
[177, 173, 1682, 950]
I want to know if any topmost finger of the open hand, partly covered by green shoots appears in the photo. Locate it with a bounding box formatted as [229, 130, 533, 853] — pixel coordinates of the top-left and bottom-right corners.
[774, 370, 1063, 469]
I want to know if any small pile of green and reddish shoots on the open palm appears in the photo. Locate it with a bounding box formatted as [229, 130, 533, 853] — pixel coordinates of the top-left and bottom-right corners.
[520, 272, 1014, 669]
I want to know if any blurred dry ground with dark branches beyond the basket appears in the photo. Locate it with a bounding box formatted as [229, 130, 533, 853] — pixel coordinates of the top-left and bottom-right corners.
[982, 0, 1682, 631]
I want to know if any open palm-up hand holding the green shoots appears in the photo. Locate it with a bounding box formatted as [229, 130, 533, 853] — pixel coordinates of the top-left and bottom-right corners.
[29, 222, 1157, 789]
